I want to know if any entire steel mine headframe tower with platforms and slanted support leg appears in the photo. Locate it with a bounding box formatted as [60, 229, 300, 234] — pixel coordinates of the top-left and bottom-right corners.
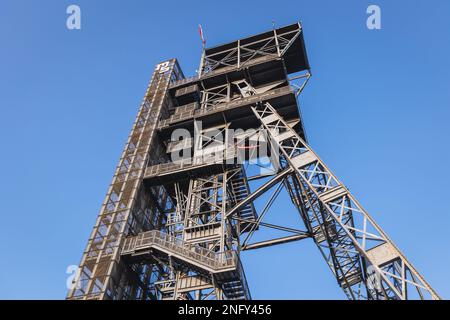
[68, 23, 439, 300]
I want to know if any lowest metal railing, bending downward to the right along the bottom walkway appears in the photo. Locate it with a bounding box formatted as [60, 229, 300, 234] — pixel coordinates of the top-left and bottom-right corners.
[122, 230, 239, 271]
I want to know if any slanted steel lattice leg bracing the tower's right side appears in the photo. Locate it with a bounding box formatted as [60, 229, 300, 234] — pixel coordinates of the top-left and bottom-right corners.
[253, 103, 439, 299]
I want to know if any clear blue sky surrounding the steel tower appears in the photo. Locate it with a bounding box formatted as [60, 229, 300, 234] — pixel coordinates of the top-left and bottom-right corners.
[0, 0, 450, 299]
